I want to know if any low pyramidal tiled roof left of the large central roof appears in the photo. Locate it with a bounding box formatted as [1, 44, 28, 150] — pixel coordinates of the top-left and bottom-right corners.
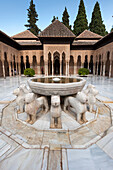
[11, 30, 38, 39]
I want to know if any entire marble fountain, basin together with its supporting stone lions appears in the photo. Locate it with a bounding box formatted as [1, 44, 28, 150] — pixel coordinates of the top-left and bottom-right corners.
[14, 76, 98, 129]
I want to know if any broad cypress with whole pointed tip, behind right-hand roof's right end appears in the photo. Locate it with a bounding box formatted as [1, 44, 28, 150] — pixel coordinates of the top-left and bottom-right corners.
[89, 2, 107, 36]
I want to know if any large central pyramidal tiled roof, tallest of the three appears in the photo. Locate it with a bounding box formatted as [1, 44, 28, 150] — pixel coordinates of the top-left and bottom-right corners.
[38, 20, 75, 38]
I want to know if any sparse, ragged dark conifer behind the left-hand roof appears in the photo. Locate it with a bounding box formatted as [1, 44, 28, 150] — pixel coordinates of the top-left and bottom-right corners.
[25, 0, 40, 35]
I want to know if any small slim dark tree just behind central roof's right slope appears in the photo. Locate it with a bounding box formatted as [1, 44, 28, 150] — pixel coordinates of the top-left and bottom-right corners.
[62, 7, 71, 29]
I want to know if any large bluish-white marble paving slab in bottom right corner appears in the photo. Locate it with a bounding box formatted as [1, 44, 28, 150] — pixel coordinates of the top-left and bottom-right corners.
[67, 145, 113, 170]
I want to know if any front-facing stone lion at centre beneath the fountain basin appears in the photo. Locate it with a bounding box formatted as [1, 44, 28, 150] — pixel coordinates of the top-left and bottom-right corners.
[50, 95, 62, 129]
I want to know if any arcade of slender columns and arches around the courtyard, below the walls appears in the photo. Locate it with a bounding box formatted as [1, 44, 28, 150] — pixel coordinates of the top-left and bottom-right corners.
[0, 51, 113, 77]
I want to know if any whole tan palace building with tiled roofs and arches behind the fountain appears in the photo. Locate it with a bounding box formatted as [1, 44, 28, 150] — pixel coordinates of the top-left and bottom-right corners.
[0, 20, 113, 77]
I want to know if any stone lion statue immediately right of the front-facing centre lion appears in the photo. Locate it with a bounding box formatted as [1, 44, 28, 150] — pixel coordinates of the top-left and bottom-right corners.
[64, 92, 87, 124]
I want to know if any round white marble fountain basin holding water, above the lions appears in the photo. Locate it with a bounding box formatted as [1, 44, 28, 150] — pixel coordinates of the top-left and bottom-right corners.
[28, 76, 86, 96]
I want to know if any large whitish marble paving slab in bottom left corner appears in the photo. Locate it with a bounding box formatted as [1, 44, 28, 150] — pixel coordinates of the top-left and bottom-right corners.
[0, 149, 43, 170]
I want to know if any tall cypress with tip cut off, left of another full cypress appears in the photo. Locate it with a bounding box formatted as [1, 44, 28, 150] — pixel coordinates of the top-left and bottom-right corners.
[73, 0, 88, 35]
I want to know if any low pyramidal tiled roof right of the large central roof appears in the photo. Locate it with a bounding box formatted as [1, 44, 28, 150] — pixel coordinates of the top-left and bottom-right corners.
[76, 30, 102, 39]
